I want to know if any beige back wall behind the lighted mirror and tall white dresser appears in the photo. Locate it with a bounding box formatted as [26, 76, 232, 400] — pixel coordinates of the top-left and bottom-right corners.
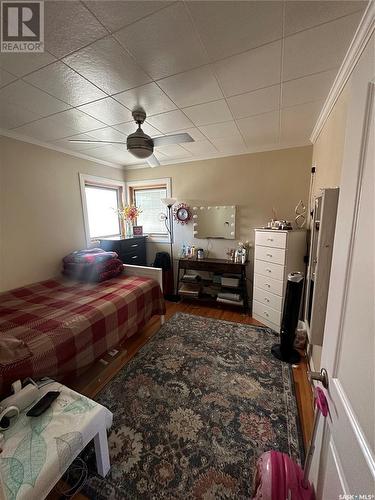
[125, 146, 312, 294]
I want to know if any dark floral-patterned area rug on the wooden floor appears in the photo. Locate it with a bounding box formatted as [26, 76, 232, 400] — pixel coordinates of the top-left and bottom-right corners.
[71, 313, 302, 500]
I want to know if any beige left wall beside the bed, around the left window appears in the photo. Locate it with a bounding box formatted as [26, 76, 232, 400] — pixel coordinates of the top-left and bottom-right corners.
[0, 137, 124, 290]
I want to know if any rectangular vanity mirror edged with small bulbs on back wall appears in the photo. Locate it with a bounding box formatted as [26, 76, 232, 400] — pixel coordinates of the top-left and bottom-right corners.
[193, 205, 236, 240]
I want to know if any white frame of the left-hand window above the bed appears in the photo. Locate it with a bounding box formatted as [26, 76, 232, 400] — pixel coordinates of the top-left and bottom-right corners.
[79, 174, 126, 246]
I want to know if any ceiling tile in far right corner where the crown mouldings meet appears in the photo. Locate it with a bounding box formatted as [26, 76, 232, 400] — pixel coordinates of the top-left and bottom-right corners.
[280, 101, 323, 144]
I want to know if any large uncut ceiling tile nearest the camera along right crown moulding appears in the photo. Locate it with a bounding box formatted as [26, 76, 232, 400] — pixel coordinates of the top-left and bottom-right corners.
[283, 13, 361, 81]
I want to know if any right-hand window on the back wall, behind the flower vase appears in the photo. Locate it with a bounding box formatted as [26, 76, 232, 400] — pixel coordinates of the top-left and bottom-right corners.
[128, 179, 171, 241]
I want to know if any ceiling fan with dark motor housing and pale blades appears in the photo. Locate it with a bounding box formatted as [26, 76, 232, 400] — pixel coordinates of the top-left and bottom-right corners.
[69, 109, 194, 167]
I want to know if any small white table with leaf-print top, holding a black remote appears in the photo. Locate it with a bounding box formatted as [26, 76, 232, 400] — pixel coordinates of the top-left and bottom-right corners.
[0, 381, 113, 500]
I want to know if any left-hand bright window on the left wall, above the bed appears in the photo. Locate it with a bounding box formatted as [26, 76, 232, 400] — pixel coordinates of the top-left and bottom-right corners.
[80, 175, 124, 243]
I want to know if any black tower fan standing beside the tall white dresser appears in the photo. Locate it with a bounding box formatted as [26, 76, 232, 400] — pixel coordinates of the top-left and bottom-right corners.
[271, 273, 303, 364]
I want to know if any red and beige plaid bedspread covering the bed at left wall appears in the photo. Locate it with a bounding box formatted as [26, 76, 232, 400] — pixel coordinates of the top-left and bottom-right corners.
[0, 275, 165, 394]
